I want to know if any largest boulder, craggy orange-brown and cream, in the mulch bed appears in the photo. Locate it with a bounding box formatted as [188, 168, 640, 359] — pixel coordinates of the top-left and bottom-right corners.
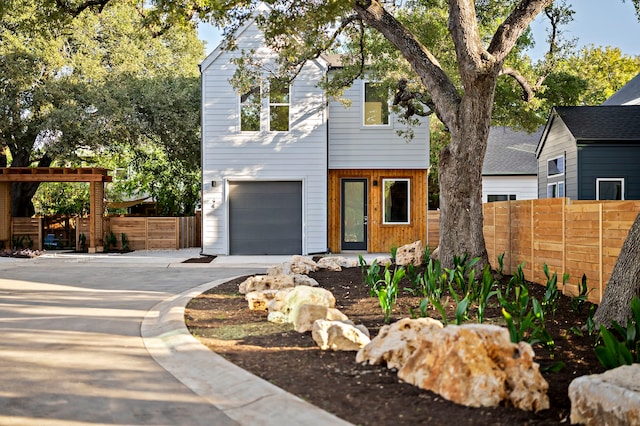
[398, 324, 549, 411]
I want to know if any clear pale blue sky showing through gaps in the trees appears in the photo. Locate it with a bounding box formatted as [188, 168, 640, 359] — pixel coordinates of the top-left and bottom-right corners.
[198, 0, 640, 59]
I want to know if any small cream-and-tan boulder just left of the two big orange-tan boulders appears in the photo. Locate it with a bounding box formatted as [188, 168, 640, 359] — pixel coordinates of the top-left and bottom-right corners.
[311, 320, 370, 351]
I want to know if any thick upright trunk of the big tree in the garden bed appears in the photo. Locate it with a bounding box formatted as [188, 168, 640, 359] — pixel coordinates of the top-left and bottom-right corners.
[438, 76, 495, 268]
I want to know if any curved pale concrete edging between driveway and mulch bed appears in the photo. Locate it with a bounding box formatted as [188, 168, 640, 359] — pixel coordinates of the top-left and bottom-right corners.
[141, 278, 350, 426]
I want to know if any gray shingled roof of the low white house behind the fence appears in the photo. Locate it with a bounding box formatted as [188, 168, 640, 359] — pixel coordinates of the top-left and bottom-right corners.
[482, 126, 543, 176]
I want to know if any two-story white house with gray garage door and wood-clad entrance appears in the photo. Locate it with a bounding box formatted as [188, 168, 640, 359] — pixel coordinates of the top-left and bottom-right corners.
[200, 4, 429, 255]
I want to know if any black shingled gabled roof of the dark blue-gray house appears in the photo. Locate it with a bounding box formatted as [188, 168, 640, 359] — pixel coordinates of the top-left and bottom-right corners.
[536, 105, 640, 156]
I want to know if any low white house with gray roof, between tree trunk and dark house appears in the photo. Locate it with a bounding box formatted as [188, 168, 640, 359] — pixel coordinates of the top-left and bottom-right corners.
[482, 126, 543, 203]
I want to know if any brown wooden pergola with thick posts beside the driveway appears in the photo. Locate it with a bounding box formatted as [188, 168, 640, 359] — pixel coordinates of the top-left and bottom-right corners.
[0, 167, 112, 253]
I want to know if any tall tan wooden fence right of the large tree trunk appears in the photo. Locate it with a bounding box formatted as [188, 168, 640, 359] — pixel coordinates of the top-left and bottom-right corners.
[483, 198, 640, 303]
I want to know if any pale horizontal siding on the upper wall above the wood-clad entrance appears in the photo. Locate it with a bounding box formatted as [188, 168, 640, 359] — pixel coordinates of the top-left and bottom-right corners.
[329, 80, 429, 169]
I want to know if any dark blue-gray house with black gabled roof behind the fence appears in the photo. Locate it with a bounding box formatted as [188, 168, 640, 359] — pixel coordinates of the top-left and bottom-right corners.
[536, 105, 640, 200]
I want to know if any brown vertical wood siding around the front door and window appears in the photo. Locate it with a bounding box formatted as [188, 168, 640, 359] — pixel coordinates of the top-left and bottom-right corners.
[328, 169, 427, 253]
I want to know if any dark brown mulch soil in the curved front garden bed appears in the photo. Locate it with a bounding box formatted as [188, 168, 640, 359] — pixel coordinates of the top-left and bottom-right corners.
[185, 268, 604, 426]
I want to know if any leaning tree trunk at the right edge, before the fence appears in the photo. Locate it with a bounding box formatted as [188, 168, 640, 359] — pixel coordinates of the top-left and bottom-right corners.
[593, 214, 640, 327]
